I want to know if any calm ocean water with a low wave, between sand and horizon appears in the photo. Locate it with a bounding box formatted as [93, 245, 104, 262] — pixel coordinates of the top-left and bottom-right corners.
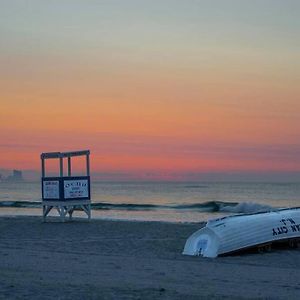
[0, 182, 300, 222]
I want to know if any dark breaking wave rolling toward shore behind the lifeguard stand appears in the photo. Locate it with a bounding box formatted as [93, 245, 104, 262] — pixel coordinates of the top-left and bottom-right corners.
[0, 201, 274, 213]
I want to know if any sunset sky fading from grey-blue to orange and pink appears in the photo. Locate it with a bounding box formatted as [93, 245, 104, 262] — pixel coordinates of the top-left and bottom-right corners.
[0, 0, 300, 180]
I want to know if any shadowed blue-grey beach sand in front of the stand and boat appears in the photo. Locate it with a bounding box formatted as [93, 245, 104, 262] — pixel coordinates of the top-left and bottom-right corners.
[0, 217, 300, 299]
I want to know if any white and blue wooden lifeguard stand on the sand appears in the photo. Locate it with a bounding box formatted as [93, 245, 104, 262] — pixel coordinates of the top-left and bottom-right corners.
[41, 150, 91, 221]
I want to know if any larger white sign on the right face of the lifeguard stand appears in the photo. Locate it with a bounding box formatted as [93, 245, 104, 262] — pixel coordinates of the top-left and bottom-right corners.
[64, 179, 89, 199]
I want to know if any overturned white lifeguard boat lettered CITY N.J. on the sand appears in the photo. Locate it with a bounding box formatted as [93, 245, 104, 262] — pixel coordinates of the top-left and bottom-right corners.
[183, 207, 300, 257]
